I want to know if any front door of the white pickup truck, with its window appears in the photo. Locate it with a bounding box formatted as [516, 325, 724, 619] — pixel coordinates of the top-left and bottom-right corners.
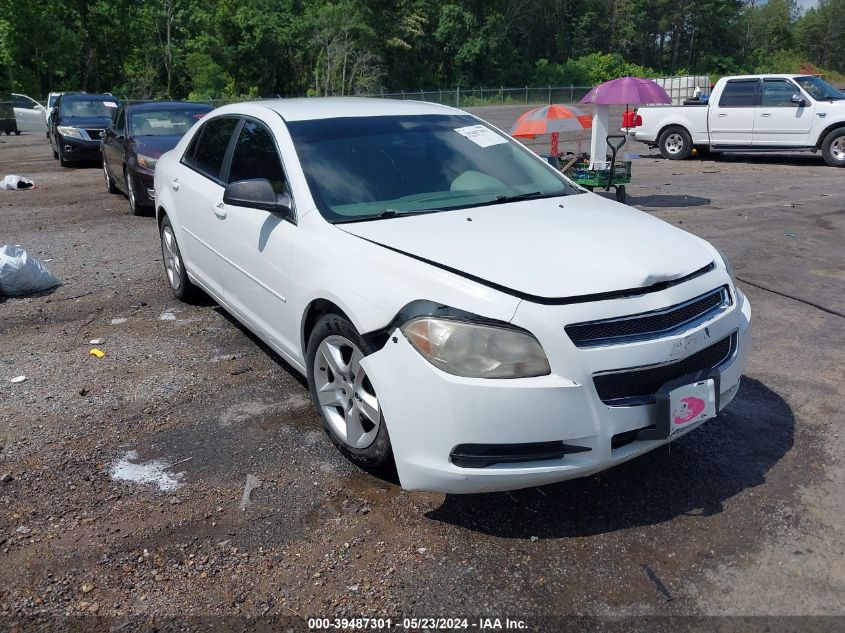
[752, 78, 816, 147]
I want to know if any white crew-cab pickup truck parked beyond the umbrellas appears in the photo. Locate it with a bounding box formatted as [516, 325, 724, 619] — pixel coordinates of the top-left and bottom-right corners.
[635, 75, 845, 167]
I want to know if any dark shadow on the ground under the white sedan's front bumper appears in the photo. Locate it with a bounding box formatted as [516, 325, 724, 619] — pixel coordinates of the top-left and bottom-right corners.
[426, 378, 795, 539]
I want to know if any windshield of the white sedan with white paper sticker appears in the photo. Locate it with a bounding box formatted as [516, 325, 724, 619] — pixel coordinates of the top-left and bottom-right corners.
[288, 115, 579, 222]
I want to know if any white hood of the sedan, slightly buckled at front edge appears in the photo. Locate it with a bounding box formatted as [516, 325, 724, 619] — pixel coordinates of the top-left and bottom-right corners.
[337, 194, 713, 299]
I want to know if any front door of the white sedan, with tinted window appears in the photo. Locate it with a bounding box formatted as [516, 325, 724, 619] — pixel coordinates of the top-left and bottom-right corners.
[213, 117, 299, 357]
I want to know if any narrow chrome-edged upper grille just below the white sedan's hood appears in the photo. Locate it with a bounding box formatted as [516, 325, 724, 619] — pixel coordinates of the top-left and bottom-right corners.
[564, 286, 731, 347]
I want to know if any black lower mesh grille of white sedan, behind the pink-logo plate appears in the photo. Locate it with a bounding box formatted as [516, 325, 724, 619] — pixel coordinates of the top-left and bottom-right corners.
[593, 334, 736, 406]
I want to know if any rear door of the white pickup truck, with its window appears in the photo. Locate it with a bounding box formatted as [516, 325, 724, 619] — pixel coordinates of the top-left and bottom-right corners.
[708, 78, 760, 147]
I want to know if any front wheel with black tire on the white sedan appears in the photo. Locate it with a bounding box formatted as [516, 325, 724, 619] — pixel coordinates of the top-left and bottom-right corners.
[305, 314, 393, 470]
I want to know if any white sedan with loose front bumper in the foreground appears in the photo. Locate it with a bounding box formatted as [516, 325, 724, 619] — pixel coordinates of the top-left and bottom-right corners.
[155, 98, 751, 493]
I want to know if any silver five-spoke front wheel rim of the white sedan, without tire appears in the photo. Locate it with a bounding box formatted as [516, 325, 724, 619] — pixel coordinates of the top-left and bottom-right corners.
[313, 335, 381, 449]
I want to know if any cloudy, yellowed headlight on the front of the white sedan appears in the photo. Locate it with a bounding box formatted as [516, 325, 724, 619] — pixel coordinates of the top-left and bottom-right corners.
[401, 317, 551, 378]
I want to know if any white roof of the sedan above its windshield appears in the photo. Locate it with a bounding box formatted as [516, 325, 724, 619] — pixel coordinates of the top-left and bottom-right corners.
[209, 97, 464, 121]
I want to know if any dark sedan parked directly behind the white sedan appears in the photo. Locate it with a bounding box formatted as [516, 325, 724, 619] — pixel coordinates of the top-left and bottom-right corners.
[102, 101, 212, 215]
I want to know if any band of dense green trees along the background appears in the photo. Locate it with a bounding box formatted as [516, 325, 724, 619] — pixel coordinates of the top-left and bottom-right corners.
[0, 0, 845, 99]
